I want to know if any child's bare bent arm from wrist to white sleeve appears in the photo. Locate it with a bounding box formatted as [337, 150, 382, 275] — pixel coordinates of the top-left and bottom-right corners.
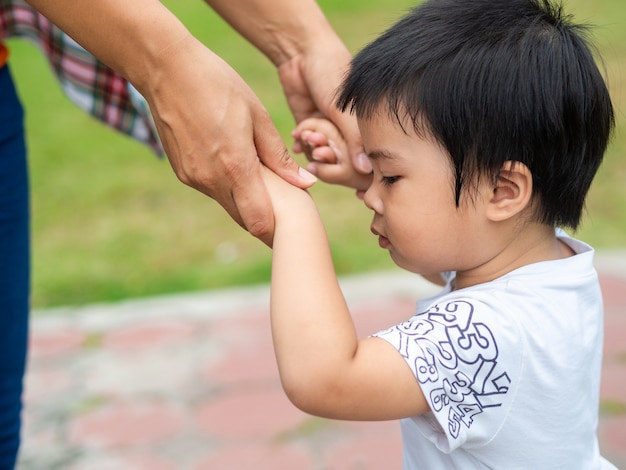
[264, 170, 429, 420]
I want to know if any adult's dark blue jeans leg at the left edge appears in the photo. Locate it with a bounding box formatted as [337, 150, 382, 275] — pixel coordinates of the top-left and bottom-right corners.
[0, 66, 30, 470]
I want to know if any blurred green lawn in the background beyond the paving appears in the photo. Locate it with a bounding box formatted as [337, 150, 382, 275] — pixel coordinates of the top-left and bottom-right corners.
[10, 0, 626, 308]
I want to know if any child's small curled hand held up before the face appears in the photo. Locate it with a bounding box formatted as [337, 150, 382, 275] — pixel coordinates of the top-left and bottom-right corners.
[291, 118, 372, 194]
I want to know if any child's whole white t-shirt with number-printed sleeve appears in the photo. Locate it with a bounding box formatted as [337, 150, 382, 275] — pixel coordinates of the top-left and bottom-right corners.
[375, 231, 615, 470]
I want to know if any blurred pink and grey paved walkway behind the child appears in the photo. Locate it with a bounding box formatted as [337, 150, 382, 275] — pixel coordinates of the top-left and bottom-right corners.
[18, 252, 626, 470]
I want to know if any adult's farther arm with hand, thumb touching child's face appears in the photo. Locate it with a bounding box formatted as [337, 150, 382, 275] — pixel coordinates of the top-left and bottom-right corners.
[205, 0, 371, 176]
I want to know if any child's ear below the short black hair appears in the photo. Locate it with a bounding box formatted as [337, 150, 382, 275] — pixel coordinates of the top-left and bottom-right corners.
[487, 161, 533, 222]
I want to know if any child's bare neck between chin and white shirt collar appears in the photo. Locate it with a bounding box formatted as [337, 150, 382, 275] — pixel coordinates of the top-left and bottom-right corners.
[454, 223, 575, 290]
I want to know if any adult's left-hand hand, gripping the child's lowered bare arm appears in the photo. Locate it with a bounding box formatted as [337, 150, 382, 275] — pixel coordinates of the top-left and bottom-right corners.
[140, 35, 315, 244]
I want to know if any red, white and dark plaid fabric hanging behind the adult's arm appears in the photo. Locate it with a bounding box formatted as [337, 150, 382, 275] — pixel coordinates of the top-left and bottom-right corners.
[0, 0, 164, 156]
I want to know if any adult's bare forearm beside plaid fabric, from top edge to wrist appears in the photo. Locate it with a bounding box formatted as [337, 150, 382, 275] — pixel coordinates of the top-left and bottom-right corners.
[27, 0, 190, 86]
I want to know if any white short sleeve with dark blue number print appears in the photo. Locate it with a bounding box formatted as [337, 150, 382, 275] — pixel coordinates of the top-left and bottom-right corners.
[375, 298, 522, 452]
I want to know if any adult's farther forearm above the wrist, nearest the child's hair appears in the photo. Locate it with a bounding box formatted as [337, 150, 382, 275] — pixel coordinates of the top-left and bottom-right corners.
[205, 0, 335, 66]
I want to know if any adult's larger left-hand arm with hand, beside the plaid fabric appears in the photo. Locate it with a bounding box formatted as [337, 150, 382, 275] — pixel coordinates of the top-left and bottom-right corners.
[28, 0, 313, 243]
